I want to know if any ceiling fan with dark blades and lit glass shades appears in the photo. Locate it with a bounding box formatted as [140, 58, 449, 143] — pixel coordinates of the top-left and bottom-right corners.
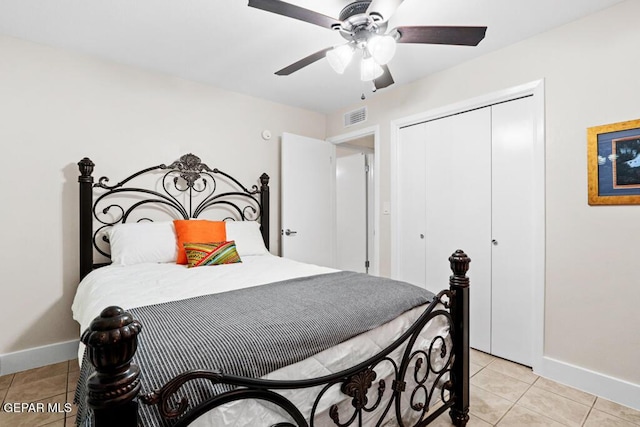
[249, 0, 487, 89]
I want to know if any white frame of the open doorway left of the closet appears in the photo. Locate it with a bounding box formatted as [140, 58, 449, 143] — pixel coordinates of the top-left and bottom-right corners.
[327, 125, 380, 276]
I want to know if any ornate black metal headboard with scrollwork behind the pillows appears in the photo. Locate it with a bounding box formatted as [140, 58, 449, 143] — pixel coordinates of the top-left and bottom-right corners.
[78, 154, 269, 279]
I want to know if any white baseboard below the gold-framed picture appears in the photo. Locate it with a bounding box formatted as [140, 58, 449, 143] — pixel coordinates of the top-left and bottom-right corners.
[534, 356, 640, 410]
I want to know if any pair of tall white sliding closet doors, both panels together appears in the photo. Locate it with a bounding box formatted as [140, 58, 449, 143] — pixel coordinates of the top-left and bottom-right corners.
[395, 97, 535, 366]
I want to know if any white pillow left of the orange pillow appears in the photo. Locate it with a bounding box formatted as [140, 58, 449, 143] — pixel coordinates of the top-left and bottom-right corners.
[107, 221, 178, 265]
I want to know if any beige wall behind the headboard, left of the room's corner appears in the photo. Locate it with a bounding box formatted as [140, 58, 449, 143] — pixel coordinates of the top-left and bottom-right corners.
[0, 36, 325, 355]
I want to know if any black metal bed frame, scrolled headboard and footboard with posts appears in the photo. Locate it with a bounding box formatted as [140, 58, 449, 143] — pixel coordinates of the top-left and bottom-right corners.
[78, 154, 470, 427]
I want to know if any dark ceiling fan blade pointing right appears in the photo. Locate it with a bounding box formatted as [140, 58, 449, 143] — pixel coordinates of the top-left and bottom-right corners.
[392, 27, 487, 46]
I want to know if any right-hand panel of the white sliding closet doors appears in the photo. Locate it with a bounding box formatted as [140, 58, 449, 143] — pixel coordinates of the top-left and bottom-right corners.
[490, 97, 534, 366]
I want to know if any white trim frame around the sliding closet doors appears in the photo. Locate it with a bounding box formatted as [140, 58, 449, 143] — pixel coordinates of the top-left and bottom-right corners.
[390, 79, 546, 372]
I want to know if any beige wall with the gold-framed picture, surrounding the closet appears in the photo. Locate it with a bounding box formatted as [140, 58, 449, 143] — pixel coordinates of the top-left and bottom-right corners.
[327, 0, 640, 385]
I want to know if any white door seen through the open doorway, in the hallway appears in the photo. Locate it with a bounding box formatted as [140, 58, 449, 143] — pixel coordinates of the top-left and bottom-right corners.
[336, 153, 367, 273]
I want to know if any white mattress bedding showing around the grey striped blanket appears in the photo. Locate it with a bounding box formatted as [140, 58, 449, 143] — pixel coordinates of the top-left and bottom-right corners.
[72, 255, 448, 427]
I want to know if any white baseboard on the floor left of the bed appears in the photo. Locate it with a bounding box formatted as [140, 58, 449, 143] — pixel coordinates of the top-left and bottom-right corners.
[0, 340, 78, 375]
